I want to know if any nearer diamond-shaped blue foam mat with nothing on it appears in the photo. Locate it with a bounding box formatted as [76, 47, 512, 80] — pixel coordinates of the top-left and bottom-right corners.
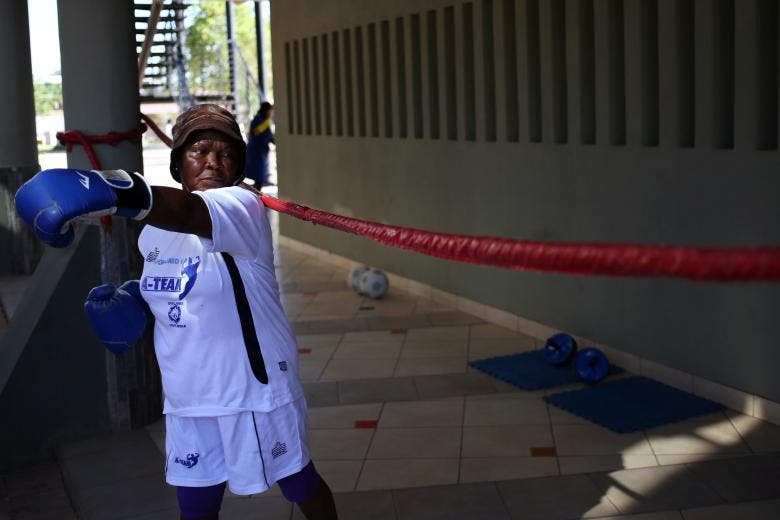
[543, 376, 724, 433]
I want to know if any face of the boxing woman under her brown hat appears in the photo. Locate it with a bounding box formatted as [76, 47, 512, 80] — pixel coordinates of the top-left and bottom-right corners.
[179, 130, 240, 192]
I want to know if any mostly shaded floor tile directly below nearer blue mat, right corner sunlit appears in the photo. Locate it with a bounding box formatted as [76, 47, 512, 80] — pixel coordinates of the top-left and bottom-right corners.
[553, 424, 653, 456]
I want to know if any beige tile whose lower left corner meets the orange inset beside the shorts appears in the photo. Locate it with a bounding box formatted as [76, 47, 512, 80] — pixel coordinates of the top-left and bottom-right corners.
[379, 397, 463, 428]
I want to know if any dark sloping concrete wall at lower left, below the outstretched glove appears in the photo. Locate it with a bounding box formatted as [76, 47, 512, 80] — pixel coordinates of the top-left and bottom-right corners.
[0, 227, 109, 471]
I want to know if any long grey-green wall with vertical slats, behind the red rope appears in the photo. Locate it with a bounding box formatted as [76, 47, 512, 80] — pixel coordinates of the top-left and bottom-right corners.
[272, 0, 780, 401]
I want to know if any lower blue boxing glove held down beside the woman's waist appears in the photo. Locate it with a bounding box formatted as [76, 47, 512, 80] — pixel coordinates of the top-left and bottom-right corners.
[84, 280, 149, 354]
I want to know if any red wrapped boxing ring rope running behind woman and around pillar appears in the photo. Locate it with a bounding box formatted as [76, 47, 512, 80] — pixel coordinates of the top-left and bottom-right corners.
[57, 114, 780, 282]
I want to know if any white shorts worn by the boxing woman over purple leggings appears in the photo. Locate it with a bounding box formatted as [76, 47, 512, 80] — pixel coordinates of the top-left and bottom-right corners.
[165, 398, 311, 495]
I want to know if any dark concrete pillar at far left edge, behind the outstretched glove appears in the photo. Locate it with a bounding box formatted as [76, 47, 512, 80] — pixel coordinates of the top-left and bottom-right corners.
[0, 0, 41, 275]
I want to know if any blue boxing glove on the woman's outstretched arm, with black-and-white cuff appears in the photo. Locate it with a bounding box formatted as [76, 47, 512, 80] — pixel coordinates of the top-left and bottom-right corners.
[16, 169, 152, 247]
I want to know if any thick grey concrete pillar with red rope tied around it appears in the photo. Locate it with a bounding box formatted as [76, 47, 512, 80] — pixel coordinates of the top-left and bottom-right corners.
[58, 0, 159, 429]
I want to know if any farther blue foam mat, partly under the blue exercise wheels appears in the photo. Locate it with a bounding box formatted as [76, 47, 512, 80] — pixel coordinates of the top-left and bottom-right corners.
[469, 350, 623, 390]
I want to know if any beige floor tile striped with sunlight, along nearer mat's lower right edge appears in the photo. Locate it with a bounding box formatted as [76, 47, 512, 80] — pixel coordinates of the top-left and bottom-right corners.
[646, 414, 750, 455]
